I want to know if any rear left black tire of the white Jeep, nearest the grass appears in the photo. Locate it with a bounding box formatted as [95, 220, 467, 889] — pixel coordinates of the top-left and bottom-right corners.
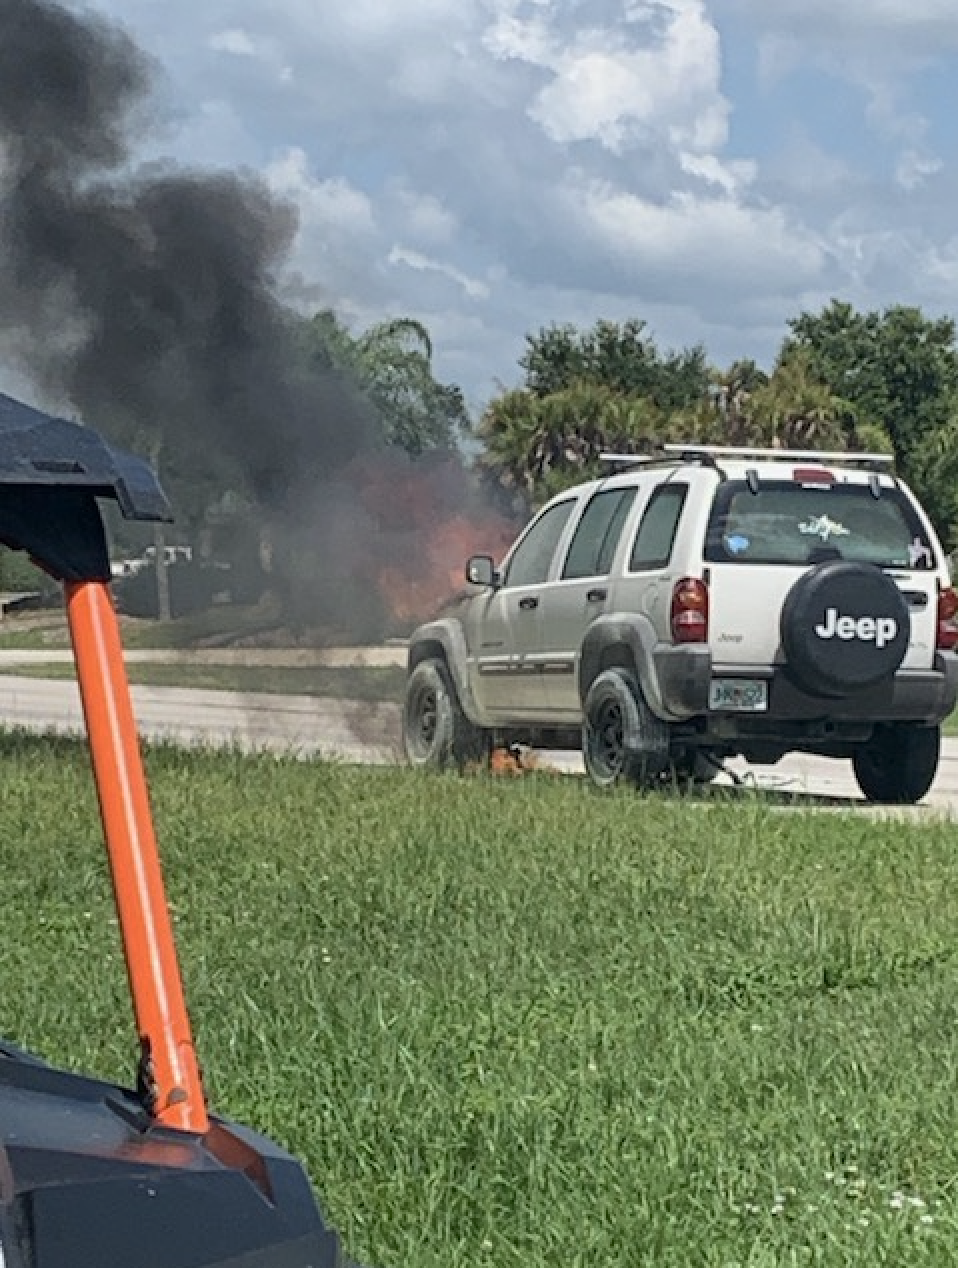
[582, 668, 669, 787]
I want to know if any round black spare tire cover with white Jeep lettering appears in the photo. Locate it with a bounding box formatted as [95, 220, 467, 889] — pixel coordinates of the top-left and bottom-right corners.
[781, 560, 911, 696]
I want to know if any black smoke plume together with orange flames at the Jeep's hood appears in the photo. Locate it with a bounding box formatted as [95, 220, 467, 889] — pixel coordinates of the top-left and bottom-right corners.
[0, 0, 514, 642]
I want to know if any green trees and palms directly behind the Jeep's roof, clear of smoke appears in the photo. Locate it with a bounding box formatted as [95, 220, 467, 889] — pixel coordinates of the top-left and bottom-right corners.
[478, 299, 958, 547]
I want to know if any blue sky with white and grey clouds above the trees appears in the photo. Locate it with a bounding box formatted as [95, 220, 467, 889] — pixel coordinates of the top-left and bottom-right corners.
[54, 0, 958, 411]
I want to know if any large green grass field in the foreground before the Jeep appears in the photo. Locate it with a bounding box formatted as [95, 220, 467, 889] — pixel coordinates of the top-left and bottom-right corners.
[0, 737, 958, 1268]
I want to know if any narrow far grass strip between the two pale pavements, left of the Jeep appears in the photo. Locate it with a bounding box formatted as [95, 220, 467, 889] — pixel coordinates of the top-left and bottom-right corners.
[0, 662, 406, 701]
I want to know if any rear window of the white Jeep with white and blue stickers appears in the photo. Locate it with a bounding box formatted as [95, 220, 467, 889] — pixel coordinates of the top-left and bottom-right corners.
[705, 481, 936, 569]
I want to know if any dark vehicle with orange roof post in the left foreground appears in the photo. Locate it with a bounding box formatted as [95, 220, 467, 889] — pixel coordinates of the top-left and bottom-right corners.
[0, 396, 348, 1268]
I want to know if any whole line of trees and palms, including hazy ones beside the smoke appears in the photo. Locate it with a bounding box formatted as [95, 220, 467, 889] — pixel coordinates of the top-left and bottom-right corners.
[117, 299, 958, 560]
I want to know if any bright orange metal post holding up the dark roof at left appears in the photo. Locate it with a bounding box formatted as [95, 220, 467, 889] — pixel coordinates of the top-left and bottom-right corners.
[65, 581, 209, 1135]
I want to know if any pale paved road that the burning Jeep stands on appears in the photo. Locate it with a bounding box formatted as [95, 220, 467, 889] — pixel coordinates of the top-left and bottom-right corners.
[0, 669, 958, 818]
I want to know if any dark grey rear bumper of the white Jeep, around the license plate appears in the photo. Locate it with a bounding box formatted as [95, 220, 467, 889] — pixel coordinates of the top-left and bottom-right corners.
[655, 647, 958, 730]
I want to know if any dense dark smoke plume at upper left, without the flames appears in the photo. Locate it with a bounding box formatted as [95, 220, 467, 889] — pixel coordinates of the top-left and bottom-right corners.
[0, 0, 400, 634]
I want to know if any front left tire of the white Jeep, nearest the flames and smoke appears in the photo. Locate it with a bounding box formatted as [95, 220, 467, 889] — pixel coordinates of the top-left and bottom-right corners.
[402, 659, 489, 771]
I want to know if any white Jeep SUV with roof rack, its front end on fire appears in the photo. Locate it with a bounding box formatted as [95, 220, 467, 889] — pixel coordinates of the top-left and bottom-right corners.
[403, 445, 958, 803]
